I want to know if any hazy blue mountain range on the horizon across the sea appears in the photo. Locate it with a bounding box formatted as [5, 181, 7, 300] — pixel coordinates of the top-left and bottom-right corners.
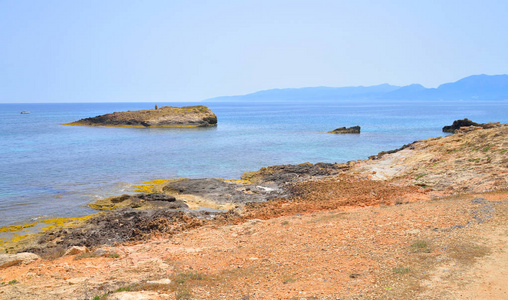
[204, 75, 508, 102]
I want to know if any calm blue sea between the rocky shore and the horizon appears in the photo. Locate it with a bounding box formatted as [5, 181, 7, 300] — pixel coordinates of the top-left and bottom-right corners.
[0, 101, 508, 226]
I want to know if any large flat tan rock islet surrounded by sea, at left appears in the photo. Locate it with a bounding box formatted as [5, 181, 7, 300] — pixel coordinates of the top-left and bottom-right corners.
[64, 105, 217, 128]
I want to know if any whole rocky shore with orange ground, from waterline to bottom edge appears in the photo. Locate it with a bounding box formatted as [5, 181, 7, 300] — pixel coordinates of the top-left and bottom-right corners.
[0, 123, 508, 299]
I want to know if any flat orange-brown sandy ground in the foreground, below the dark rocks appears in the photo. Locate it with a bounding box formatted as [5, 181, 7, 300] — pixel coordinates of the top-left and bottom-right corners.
[0, 193, 508, 299]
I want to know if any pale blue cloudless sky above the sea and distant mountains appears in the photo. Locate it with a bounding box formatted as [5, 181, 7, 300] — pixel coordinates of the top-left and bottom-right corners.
[0, 0, 508, 103]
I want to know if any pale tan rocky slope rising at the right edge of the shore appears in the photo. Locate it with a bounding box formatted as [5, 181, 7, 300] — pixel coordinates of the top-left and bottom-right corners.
[351, 123, 508, 193]
